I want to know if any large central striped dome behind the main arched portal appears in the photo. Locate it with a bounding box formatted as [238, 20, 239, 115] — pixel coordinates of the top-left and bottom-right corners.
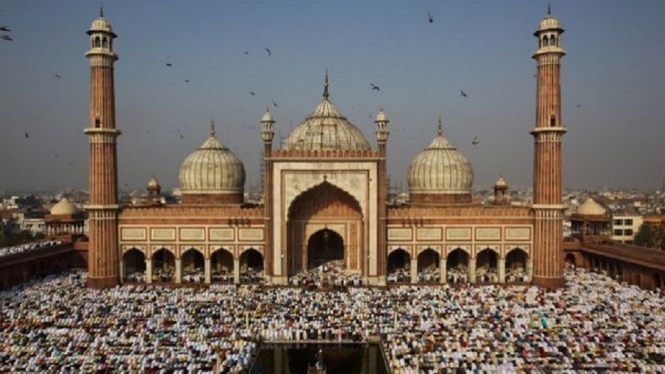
[282, 74, 371, 151]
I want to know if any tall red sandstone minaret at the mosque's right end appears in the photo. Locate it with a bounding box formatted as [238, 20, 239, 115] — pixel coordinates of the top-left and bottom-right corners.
[531, 8, 566, 289]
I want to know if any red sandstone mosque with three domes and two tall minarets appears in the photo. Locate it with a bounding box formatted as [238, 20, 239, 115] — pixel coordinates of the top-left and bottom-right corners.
[80, 12, 566, 288]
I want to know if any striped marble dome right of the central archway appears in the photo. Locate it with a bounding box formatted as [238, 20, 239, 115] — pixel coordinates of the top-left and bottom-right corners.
[408, 119, 473, 194]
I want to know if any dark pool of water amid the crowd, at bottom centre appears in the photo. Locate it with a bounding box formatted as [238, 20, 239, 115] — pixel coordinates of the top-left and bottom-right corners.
[249, 343, 388, 374]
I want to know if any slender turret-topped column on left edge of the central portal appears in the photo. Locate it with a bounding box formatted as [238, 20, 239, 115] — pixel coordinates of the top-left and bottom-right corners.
[261, 107, 280, 278]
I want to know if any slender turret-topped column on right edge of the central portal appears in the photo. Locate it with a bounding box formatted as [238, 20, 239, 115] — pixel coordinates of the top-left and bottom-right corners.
[374, 108, 390, 285]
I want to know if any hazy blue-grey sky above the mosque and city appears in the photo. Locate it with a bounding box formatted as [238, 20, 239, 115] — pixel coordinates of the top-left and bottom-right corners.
[0, 0, 665, 190]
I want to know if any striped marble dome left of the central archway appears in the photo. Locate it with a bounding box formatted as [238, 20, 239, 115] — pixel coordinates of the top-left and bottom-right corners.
[180, 123, 245, 194]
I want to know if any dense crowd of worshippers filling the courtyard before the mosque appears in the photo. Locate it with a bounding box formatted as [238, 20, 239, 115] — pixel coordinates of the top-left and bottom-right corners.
[0, 269, 665, 374]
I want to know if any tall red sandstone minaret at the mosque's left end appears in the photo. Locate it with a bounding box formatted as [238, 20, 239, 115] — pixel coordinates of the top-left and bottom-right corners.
[84, 11, 120, 288]
